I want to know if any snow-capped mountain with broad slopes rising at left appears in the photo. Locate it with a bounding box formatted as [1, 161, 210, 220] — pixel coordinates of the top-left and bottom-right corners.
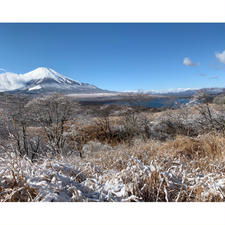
[0, 67, 108, 94]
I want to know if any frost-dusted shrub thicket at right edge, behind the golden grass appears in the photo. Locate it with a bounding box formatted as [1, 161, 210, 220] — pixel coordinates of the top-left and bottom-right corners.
[147, 104, 225, 140]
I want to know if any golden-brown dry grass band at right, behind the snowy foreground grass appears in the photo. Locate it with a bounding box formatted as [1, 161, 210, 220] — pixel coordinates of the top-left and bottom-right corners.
[85, 133, 225, 170]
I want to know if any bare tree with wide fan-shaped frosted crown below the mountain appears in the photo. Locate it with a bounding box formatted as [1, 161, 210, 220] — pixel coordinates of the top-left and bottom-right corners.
[26, 94, 79, 154]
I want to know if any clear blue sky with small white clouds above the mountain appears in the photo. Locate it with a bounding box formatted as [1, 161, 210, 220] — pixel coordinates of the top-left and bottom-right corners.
[0, 23, 225, 91]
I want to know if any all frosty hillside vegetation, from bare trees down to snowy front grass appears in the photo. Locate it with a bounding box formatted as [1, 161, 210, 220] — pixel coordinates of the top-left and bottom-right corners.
[0, 95, 225, 202]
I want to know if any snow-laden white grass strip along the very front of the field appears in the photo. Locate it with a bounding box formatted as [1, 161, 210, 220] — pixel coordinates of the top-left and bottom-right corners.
[0, 151, 225, 202]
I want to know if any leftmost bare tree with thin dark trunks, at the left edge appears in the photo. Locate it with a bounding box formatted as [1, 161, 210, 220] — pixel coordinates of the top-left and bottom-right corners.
[0, 96, 47, 161]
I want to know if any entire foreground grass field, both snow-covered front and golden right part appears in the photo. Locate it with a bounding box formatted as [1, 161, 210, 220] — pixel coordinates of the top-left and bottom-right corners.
[0, 134, 225, 202]
